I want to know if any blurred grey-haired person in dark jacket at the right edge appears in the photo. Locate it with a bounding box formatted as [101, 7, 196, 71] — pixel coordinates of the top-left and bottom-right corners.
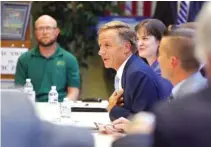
[154, 2, 211, 147]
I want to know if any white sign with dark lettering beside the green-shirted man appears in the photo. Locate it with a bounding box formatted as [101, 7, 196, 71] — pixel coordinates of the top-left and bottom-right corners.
[0, 48, 28, 75]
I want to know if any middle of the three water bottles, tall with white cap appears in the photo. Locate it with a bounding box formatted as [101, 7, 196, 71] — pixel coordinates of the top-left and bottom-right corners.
[48, 86, 60, 122]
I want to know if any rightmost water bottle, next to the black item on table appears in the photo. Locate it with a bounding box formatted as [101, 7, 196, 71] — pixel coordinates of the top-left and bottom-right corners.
[60, 98, 71, 118]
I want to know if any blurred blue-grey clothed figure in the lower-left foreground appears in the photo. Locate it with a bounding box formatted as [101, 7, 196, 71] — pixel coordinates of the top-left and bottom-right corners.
[0, 89, 94, 147]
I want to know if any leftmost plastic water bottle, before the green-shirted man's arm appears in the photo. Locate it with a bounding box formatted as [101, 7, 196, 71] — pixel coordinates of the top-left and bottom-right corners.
[24, 79, 36, 104]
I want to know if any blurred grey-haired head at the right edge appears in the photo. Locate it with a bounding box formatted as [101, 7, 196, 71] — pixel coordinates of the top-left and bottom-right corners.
[195, 2, 211, 79]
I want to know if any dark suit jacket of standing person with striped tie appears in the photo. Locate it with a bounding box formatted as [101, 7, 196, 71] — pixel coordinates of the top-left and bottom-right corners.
[153, 1, 204, 26]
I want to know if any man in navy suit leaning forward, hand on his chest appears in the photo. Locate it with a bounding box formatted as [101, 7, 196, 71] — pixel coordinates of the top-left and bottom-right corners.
[98, 21, 163, 120]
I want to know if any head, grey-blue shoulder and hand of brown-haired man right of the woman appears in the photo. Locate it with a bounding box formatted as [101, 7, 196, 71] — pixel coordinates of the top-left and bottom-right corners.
[99, 28, 207, 136]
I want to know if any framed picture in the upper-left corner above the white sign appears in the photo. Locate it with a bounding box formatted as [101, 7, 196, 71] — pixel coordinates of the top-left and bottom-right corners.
[1, 2, 31, 40]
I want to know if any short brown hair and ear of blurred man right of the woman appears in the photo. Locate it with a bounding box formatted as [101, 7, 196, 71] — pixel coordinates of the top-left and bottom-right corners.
[163, 28, 200, 72]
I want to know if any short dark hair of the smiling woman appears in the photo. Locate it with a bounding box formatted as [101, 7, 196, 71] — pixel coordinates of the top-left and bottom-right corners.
[135, 19, 166, 41]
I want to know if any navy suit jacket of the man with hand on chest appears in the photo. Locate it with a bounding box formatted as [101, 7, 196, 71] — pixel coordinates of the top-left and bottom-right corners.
[109, 55, 162, 120]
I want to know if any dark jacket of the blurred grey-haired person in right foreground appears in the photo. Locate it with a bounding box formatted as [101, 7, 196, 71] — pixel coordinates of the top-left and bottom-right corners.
[153, 85, 211, 147]
